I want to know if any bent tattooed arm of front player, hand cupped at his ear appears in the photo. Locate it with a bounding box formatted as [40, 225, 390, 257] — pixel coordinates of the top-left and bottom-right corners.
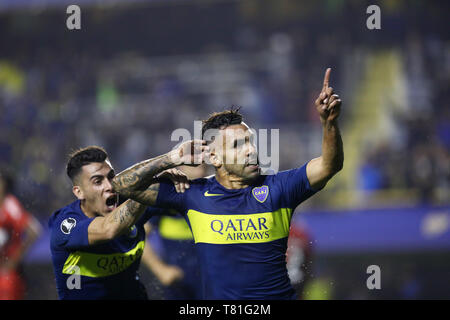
[112, 140, 209, 206]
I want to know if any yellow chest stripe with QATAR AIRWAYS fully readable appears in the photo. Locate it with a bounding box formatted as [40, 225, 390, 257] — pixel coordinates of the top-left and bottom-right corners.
[187, 208, 292, 244]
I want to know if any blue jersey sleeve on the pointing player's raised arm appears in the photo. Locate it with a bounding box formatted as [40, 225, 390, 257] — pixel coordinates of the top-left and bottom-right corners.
[277, 163, 319, 209]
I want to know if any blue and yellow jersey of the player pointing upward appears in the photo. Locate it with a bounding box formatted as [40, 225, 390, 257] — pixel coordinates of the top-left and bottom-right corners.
[157, 164, 316, 299]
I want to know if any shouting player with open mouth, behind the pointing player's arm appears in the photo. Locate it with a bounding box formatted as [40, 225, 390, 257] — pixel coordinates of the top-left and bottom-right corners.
[49, 142, 207, 300]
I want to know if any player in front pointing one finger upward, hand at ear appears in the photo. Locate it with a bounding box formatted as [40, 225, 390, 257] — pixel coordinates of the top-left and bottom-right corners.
[112, 69, 344, 299]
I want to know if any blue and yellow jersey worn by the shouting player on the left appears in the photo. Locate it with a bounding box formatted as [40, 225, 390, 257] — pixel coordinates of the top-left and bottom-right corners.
[49, 200, 149, 300]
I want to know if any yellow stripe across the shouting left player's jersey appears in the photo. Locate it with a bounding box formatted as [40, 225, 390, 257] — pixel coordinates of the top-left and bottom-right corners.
[62, 241, 145, 278]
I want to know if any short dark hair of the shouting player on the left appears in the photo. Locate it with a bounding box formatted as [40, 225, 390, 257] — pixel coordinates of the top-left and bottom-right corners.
[66, 146, 108, 181]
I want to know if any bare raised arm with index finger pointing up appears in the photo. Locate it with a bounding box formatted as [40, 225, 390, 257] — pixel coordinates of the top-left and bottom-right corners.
[306, 68, 344, 190]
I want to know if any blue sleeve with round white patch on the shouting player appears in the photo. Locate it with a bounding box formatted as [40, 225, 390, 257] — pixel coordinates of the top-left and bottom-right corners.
[51, 214, 95, 250]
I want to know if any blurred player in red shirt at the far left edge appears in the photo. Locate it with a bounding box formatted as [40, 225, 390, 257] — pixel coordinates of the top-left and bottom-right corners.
[0, 173, 41, 300]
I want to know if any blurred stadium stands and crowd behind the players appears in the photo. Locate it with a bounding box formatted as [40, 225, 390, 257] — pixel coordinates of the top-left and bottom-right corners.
[0, 0, 450, 299]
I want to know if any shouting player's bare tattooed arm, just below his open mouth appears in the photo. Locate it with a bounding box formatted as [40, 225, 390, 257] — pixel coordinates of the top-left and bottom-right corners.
[88, 200, 146, 245]
